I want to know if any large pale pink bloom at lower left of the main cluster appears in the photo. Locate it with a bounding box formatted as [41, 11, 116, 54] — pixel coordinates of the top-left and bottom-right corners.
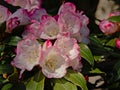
[12, 37, 41, 78]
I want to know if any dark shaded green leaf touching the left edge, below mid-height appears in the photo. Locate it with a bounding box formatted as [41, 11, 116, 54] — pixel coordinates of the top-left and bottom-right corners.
[0, 64, 13, 74]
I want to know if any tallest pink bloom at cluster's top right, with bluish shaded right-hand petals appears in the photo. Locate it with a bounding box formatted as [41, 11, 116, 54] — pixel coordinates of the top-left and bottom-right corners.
[58, 2, 89, 44]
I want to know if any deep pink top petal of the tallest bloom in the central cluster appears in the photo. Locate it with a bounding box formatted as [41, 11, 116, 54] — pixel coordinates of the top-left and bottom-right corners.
[58, 2, 76, 14]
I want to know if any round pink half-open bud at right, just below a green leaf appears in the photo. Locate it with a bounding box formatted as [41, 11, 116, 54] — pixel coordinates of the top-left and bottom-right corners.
[99, 20, 118, 35]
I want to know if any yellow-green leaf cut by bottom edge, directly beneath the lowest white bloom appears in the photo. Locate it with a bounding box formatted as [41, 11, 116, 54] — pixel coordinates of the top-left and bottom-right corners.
[53, 79, 77, 90]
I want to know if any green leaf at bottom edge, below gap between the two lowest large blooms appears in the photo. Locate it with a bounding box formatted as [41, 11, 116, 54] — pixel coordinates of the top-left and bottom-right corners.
[26, 71, 45, 90]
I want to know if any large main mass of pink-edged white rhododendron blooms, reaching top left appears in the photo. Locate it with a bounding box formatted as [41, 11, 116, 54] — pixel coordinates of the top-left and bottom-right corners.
[3, 0, 89, 78]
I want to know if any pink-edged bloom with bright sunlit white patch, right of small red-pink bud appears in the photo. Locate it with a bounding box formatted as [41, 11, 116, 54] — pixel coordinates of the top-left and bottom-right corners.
[54, 33, 81, 69]
